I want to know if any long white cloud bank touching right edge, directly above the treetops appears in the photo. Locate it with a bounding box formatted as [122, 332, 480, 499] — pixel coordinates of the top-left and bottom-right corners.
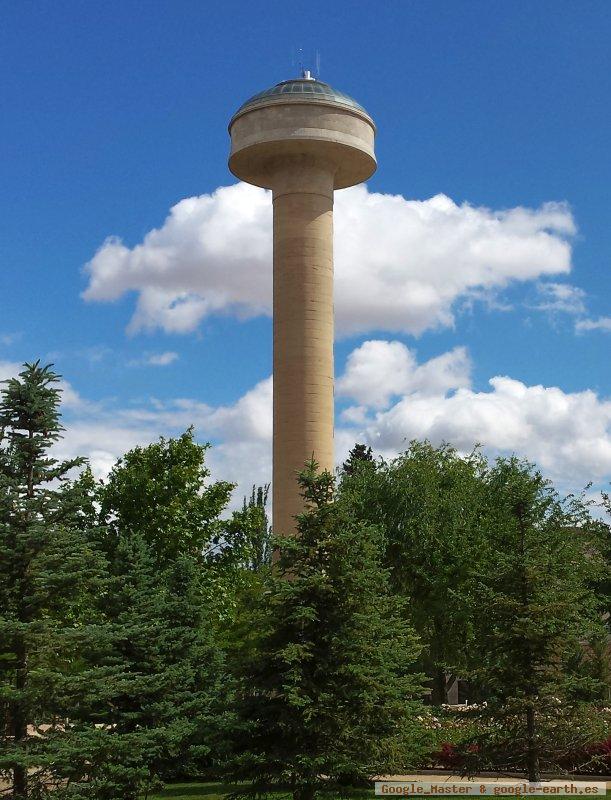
[343, 362, 611, 488]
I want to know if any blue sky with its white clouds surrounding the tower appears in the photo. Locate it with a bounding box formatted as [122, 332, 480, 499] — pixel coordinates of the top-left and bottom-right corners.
[0, 0, 611, 500]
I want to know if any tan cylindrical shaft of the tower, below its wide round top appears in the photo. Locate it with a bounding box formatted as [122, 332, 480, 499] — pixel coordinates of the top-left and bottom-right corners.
[270, 157, 334, 535]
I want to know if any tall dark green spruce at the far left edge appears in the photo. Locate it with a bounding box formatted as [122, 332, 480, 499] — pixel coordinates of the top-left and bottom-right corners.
[0, 362, 104, 800]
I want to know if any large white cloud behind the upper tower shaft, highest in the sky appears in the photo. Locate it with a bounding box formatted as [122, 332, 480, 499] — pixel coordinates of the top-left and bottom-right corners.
[84, 183, 575, 335]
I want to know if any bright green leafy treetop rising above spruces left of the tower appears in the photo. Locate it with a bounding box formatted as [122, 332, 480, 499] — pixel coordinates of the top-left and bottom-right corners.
[100, 428, 233, 565]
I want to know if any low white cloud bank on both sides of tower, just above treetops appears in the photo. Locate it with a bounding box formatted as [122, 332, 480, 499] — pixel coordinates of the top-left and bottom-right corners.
[39, 340, 611, 507]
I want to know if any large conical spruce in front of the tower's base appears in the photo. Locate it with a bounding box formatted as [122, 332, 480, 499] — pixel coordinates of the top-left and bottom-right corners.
[233, 463, 430, 800]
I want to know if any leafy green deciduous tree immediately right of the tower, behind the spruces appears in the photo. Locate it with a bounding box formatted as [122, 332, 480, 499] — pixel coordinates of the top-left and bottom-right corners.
[340, 442, 486, 704]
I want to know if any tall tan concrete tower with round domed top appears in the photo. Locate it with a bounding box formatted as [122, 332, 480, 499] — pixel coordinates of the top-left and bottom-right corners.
[229, 71, 376, 535]
